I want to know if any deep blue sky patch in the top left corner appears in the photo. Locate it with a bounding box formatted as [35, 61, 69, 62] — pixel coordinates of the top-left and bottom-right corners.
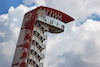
[0, 0, 35, 15]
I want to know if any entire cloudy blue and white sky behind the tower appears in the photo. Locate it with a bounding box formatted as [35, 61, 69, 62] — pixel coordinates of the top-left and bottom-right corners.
[0, 0, 100, 67]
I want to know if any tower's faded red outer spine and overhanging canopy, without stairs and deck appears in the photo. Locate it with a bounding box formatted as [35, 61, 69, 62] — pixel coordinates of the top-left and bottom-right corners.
[12, 6, 74, 67]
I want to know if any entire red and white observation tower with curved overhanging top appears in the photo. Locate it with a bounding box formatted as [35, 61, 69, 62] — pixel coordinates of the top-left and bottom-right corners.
[12, 6, 74, 67]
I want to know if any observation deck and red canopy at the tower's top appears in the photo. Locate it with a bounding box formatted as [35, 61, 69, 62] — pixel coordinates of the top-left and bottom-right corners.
[25, 6, 74, 33]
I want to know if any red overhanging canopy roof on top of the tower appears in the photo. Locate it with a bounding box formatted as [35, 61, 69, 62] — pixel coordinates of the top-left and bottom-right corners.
[26, 6, 74, 23]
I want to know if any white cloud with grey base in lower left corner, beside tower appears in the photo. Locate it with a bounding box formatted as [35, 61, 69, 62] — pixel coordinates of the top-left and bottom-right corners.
[0, 40, 16, 67]
